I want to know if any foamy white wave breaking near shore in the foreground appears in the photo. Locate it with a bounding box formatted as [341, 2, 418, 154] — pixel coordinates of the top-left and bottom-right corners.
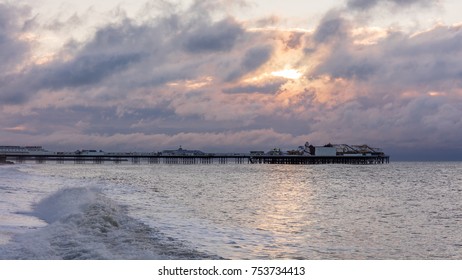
[0, 187, 218, 260]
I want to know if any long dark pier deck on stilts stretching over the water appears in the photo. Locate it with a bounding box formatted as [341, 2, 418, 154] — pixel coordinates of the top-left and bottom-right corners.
[3, 153, 390, 165]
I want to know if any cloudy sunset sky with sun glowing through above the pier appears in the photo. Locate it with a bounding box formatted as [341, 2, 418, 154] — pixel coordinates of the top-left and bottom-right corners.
[0, 0, 462, 160]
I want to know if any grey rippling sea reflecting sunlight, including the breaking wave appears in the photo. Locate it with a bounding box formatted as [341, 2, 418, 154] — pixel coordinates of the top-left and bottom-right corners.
[0, 162, 462, 260]
